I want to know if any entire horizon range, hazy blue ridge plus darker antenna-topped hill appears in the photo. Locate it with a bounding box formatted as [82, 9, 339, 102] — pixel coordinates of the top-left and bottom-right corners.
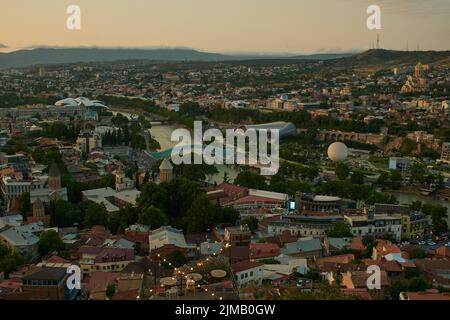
[0, 48, 450, 69]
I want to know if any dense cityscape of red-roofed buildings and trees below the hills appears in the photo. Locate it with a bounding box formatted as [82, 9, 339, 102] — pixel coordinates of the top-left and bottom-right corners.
[0, 49, 450, 300]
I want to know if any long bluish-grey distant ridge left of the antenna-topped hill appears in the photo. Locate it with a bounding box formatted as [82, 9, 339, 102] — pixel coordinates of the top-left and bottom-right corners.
[0, 48, 358, 69]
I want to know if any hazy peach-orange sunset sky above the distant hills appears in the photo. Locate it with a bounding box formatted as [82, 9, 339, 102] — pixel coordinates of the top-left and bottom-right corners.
[0, 0, 450, 53]
